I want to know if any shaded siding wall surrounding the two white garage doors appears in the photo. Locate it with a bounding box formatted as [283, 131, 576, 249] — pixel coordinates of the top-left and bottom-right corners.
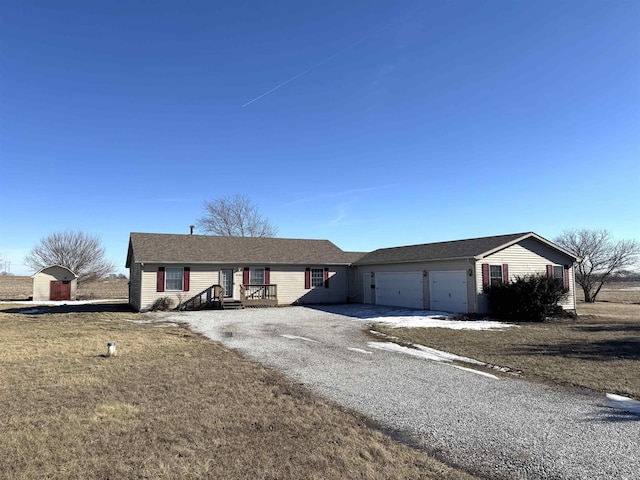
[353, 260, 475, 312]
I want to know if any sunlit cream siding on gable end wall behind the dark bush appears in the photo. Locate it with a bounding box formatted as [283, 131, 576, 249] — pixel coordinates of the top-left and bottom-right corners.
[475, 238, 576, 313]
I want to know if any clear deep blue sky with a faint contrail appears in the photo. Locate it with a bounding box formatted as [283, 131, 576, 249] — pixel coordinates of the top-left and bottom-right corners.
[0, 0, 640, 274]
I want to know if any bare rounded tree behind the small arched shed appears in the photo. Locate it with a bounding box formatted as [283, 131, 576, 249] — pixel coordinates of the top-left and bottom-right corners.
[24, 231, 114, 283]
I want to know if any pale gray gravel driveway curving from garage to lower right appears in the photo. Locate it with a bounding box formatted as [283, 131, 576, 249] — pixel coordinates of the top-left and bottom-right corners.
[169, 305, 640, 479]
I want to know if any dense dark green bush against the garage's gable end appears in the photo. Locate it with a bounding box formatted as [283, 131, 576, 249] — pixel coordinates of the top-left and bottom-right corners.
[486, 275, 566, 322]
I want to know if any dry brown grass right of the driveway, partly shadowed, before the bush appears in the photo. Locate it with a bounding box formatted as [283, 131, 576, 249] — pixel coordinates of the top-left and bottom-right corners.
[375, 302, 640, 398]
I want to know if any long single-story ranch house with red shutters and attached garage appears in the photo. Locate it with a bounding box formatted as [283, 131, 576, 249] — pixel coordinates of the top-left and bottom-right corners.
[126, 232, 577, 314]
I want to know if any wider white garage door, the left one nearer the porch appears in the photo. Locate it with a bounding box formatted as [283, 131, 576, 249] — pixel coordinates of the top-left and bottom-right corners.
[375, 272, 424, 308]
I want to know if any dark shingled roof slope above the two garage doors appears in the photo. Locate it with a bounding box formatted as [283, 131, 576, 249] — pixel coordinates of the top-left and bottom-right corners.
[354, 232, 537, 265]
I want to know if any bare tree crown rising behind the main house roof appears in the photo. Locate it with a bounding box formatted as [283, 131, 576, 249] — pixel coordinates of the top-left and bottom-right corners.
[198, 195, 278, 237]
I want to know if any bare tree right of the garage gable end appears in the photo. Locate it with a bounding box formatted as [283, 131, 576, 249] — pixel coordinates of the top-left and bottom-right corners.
[555, 229, 640, 302]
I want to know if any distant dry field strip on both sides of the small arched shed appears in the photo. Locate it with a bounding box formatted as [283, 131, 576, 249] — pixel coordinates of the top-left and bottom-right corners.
[0, 275, 129, 300]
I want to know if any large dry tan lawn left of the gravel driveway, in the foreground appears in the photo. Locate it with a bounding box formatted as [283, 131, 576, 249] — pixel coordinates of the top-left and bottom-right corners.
[0, 311, 470, 479]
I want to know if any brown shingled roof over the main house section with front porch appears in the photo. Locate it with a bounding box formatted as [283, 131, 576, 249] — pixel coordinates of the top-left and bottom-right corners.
[126, 233, 352, 267]
